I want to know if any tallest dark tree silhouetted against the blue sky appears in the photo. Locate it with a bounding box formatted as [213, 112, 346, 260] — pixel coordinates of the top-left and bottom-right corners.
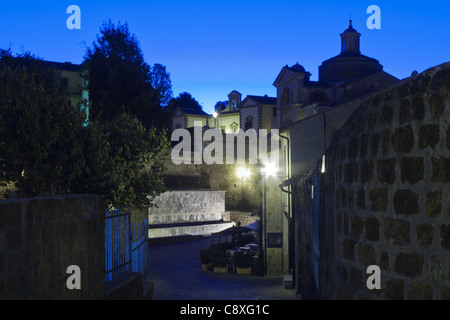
[84, 21, 171, 128]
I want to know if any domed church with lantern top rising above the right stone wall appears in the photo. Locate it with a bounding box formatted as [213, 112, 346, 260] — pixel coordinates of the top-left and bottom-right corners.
[273, 20, 398, 129]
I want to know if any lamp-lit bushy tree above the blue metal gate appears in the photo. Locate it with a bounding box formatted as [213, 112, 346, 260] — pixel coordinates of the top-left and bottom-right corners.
[74, 114, 169, 208]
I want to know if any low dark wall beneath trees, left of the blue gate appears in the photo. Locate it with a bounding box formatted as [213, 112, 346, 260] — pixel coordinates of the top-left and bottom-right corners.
[0, 195, 105, 299]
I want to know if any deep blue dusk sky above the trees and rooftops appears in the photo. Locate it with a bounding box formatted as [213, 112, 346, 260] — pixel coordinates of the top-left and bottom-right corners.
[0, 0, 450, 113]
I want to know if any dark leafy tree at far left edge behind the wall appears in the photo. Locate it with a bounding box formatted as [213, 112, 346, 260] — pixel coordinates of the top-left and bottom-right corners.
[0, 50, 86, 196]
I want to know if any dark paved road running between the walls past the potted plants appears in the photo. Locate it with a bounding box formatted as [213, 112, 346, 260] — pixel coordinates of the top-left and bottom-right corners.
[149, 237, 299, 300]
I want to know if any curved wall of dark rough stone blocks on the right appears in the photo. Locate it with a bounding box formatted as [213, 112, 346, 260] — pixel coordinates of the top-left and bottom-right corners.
[294, 63, 450, 299]
